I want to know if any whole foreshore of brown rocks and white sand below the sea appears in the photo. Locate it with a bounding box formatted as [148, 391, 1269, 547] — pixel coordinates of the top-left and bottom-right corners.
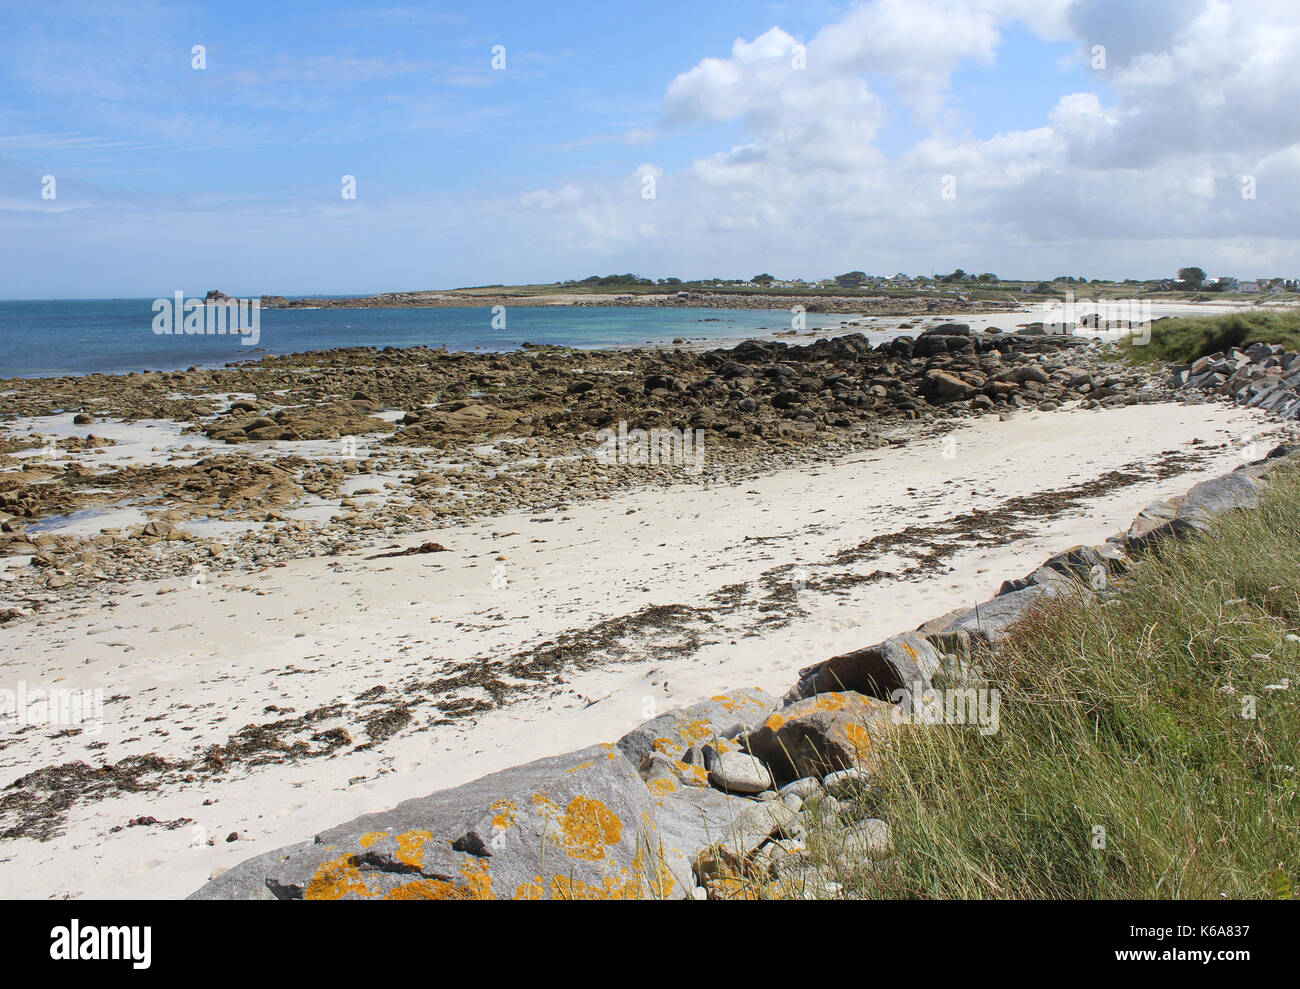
[0, 320, 1290, 897]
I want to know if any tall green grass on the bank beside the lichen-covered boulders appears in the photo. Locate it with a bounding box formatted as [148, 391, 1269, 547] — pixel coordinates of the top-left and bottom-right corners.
[844, 469, 1300, 899]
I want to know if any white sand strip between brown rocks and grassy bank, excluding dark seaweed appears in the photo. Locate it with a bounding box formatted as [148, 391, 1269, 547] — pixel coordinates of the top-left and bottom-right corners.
[0, 392, 1282, 898]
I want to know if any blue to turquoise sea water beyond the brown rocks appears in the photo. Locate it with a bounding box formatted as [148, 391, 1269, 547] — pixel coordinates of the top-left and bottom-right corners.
[0, 299, 863, 378]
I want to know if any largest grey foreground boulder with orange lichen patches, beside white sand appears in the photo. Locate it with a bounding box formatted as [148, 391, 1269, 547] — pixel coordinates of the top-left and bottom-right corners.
[194, 745, 694, 899]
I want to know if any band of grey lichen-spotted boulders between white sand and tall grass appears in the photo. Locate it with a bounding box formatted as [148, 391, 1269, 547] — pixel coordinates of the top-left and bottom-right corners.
[192, 436, 1296, 899]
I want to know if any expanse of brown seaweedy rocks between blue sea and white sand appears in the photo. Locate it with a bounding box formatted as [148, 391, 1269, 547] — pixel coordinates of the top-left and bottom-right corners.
[0, 322, 1174, 620]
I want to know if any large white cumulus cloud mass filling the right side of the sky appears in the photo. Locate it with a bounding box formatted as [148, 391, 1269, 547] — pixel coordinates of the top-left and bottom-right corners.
[514, 0, 1300, 274]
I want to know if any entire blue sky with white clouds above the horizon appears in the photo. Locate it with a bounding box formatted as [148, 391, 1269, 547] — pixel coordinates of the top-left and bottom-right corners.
[0, 0, 1300, 299]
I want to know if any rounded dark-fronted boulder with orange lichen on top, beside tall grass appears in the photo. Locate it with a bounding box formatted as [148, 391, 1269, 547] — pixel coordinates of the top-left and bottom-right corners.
[741, 690, 893, 781]
